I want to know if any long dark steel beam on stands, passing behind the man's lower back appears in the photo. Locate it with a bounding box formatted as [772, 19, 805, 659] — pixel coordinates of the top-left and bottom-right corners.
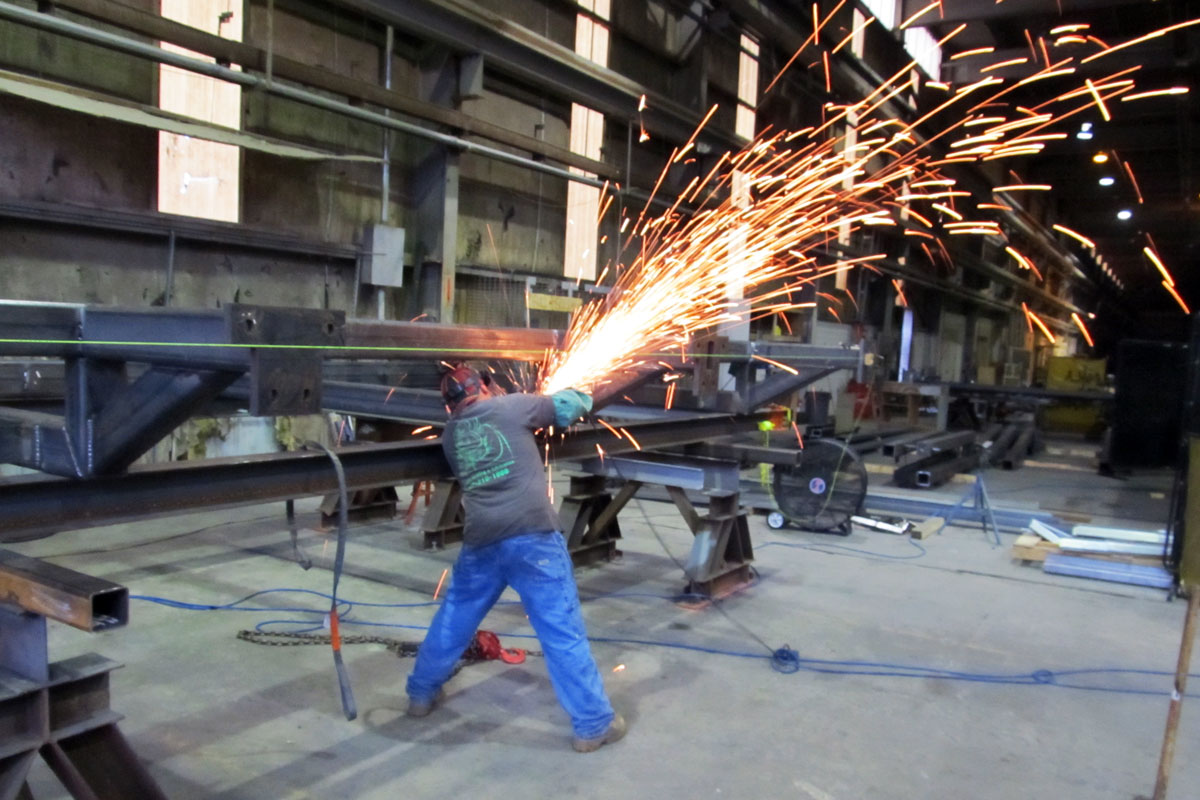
[0, 414, 768, 534]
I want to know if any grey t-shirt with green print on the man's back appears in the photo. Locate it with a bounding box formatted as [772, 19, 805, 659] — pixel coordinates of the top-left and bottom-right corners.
[442, 395, 558, 547]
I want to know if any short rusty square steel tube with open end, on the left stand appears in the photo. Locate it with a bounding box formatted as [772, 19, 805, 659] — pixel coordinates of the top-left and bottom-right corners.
[0, 549, 130, 631]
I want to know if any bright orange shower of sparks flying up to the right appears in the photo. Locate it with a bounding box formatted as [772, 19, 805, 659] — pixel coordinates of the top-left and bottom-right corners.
[538, 15, 1200, 398]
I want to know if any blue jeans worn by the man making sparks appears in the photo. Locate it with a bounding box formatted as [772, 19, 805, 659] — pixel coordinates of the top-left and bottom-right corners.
[407, 531, 613, 739]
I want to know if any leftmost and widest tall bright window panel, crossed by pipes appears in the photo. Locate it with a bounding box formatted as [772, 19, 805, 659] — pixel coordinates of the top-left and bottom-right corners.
[158, 0, 242, 222]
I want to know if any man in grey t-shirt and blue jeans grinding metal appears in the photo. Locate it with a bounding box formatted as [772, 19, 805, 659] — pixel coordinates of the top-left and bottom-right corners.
[407, 366, 625, 752]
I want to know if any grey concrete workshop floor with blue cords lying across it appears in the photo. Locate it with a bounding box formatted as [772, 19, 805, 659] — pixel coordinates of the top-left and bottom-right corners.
[13, 443, 1200, 800]
